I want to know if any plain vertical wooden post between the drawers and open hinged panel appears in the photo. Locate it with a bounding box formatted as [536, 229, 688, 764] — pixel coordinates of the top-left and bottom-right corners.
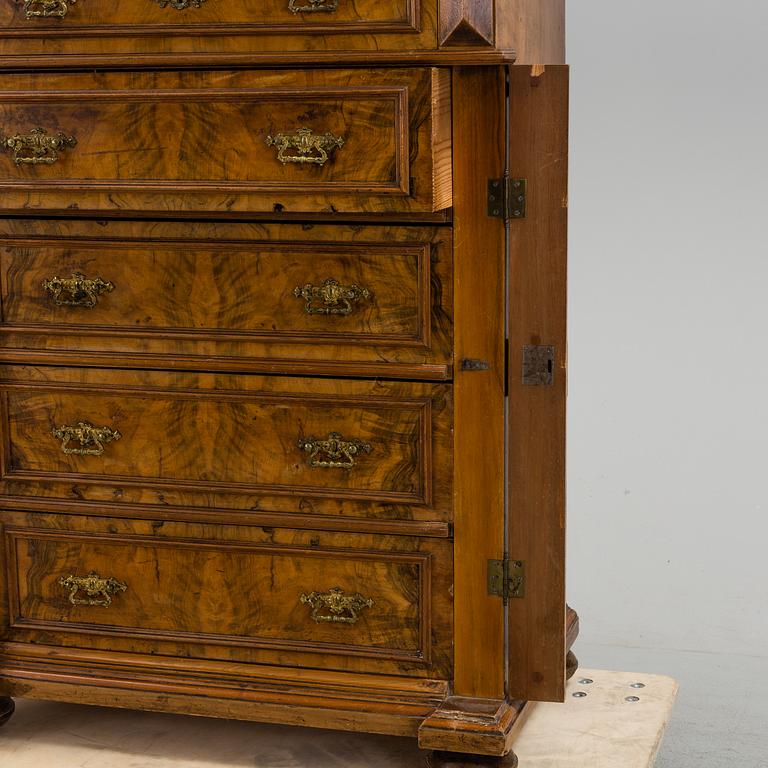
[453, 68, 505, 699]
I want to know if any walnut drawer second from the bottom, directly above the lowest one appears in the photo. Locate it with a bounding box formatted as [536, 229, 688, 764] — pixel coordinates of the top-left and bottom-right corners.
[0, 367, 452, 517]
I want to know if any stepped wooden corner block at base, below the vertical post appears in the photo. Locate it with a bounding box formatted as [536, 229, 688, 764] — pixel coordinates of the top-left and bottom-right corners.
[419, 696, 534, 765]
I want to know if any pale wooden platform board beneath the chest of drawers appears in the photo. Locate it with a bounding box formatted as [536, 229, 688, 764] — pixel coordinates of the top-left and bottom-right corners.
[0, 669, 680, 768]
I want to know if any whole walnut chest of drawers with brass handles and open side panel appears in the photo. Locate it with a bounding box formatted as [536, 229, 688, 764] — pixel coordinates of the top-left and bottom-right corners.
[0, 0, 578, 765]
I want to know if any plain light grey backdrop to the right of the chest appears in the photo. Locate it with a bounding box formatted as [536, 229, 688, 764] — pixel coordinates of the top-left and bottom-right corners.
[568, 0, 768, 768]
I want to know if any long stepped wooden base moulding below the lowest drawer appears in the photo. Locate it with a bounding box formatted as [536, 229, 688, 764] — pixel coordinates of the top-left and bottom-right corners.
[0, 643, 446, 736]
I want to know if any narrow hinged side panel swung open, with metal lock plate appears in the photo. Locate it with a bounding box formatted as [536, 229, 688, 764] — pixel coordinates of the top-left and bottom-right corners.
[507, 66, 568, 701]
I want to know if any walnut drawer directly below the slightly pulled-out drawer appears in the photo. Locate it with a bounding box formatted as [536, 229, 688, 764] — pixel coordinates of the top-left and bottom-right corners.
[0, 220, 452, 378]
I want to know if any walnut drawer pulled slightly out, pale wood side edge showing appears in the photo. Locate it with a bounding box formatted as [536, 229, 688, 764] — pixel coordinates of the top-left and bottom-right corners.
[0, 69, 451, 216]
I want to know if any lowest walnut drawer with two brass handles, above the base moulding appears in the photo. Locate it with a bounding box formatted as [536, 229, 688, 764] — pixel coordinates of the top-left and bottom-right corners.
[0, 513, 451, 675]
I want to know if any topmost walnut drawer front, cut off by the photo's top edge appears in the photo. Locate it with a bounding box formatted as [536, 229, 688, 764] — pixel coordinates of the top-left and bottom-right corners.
[0, 0, 437, 56]
